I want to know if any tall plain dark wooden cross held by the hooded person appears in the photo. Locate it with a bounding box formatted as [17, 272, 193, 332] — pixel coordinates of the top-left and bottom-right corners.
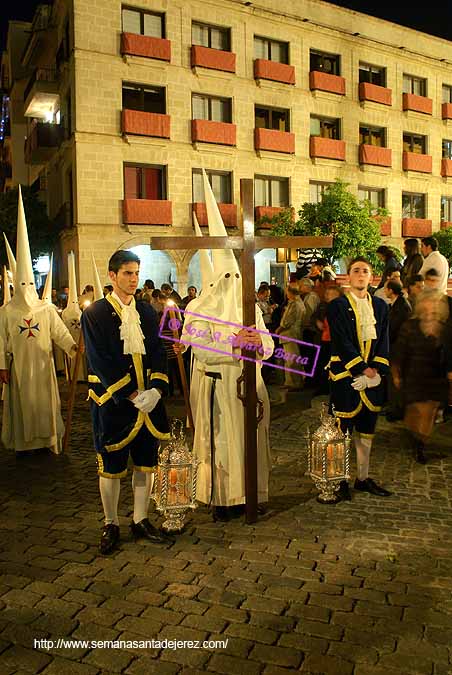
[151, 178, 333, 524]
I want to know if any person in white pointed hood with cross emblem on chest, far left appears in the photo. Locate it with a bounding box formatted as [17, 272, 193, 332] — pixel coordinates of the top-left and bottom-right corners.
[0, 187, 76, 454]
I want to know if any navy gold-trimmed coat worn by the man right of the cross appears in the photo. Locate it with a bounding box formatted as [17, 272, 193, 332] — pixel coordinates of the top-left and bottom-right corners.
[327, 293, 389, 417]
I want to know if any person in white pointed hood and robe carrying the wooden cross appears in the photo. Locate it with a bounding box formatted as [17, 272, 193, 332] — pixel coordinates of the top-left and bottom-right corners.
[182, 171, 274, 520]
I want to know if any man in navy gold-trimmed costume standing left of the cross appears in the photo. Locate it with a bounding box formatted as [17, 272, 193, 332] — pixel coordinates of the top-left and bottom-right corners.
[81, 251, 169, 555]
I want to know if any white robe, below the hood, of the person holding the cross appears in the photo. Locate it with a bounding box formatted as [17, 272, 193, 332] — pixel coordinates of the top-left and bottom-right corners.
[189, 308, 274, 506]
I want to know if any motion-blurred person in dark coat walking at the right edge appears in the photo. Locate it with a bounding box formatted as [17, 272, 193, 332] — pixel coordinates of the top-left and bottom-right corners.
[392, 290, 449, 464]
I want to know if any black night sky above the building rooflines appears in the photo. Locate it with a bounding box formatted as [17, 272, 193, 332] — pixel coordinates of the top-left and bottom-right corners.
[0, 0, 452, 49]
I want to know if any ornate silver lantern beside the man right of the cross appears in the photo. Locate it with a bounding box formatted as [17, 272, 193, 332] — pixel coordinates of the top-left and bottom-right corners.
[308, 404, 350, 504]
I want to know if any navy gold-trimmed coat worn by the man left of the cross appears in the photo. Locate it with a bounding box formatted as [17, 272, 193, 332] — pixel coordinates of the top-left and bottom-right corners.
[81, 295, 169, 452]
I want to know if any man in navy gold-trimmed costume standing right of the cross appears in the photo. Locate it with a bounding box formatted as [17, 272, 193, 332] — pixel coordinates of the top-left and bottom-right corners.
[327, 257, 391, 500]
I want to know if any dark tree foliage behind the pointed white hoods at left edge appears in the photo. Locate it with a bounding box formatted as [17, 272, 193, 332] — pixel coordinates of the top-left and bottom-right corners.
[0, 187, 61, 264]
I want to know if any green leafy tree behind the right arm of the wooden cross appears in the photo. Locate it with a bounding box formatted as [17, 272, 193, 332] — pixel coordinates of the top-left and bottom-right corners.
[267, 180, 388, 271]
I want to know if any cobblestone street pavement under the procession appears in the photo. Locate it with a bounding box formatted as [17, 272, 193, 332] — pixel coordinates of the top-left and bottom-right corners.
[0, 385, 452, 675]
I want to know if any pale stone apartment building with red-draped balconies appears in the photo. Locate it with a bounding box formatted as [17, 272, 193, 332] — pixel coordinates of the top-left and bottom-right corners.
[2, 0, 452, 288]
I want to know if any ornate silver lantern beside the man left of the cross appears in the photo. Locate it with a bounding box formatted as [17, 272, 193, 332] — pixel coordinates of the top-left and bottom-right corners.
[154, 419, 198, 532]
